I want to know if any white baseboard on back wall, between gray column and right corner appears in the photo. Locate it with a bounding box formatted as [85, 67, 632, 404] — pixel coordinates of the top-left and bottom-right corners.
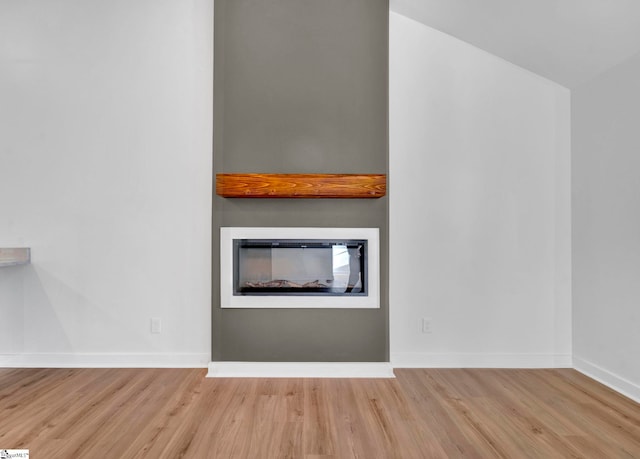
[391, 352, 572, 368]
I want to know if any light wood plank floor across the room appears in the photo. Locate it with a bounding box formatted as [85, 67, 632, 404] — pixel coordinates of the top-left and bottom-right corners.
[0, 369, 640, 459]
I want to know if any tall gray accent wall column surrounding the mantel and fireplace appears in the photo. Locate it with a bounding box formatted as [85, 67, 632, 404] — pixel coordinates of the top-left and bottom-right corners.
[212, 0, 389, 362]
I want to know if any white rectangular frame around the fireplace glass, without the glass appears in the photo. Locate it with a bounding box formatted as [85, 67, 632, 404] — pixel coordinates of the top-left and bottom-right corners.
[220, 227, 380, 309]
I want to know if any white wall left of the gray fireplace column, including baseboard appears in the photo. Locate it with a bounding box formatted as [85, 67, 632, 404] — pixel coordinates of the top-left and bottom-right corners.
[0, 0, 213, 366]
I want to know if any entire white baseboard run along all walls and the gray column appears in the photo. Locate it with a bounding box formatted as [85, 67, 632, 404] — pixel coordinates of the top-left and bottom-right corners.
[0, 352, 640, 403]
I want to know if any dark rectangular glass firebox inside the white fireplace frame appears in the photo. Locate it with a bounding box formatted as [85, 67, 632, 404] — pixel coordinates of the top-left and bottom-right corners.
[233, 239, 367, 296]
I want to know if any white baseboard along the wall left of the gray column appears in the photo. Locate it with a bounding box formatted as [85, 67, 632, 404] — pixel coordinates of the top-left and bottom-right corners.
[0, 354, 211, 368]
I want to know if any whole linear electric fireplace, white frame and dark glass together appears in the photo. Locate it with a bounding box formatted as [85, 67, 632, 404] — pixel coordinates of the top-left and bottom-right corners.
[220, 228, 380, 308]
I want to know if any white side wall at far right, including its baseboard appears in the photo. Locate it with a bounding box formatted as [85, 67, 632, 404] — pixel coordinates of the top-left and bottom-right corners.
[572, 54, 640, 400]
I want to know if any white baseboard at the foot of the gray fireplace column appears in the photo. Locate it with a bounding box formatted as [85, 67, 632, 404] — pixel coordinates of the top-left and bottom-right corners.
[207, 362, 395, 378]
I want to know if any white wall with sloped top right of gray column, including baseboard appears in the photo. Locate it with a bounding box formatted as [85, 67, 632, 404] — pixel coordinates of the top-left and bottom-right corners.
[389, 13, 571, 367]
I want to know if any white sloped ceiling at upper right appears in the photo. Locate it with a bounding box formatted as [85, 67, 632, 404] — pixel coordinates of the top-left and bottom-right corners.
[390, 0, 640, 88]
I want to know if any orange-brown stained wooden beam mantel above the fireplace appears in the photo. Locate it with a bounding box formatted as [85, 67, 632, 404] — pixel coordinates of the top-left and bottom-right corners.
[216, 174, 387, 199]
